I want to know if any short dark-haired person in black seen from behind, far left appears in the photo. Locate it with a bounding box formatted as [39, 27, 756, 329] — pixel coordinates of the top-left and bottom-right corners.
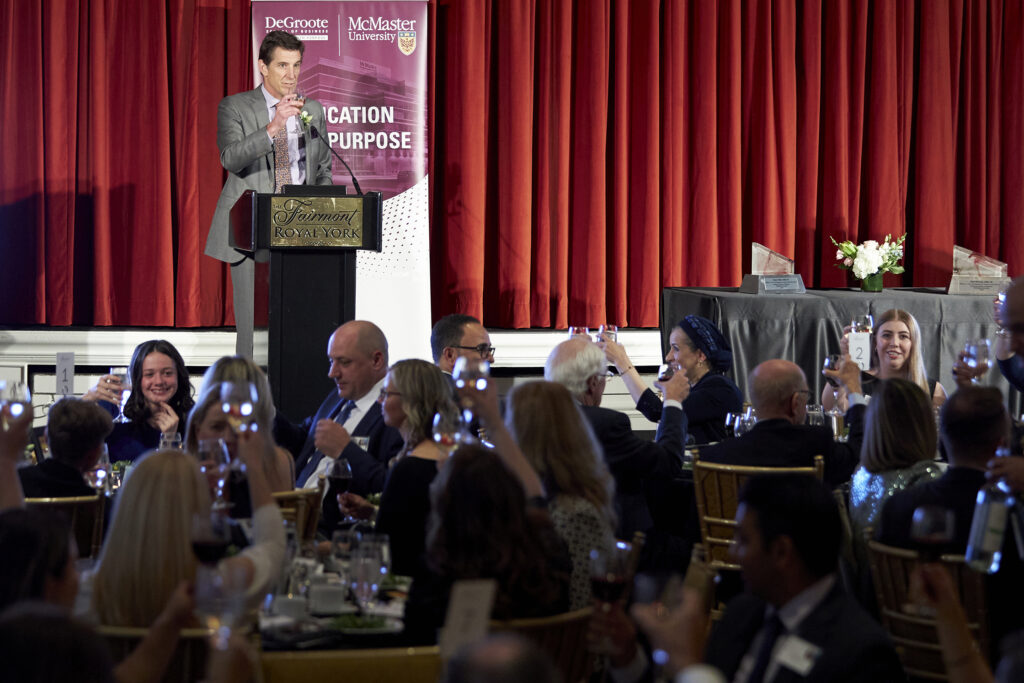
[17, 397, 114, 498]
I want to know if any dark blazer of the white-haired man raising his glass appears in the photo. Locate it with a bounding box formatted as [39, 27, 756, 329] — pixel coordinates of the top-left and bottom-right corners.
[581, 405, 687, 539]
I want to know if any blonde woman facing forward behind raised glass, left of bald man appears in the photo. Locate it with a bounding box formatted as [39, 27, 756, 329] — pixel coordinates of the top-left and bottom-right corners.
[185, 355, 295, 492]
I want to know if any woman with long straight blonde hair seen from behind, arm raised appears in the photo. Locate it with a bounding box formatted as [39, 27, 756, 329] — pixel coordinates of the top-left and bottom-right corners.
[83, 432, 285, 627]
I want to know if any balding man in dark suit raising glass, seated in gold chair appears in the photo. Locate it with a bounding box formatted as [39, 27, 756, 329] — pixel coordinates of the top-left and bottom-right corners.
[700, 359, 865, 486]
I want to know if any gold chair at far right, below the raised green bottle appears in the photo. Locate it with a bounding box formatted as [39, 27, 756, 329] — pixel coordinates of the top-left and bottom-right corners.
[867, 541, 990, 681]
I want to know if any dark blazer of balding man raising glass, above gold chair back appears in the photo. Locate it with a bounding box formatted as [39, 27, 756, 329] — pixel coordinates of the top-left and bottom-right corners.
[700, 405, 864, 487]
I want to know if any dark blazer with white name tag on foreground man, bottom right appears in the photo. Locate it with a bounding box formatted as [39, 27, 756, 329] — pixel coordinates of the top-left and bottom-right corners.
[705, 580, 906, 683]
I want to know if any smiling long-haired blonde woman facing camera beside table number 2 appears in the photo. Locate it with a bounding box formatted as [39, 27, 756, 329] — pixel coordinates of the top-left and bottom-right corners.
[821, 308, 946, 411]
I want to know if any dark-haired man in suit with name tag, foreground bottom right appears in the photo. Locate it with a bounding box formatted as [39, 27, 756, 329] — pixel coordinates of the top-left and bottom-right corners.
[635, 474, 905, 683]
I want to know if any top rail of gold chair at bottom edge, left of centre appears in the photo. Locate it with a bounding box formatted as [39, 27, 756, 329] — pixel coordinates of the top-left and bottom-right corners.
[260, 645, 441, 683]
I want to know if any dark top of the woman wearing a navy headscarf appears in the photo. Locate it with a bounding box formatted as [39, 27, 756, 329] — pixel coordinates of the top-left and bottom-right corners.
[637, 373, 743, 443]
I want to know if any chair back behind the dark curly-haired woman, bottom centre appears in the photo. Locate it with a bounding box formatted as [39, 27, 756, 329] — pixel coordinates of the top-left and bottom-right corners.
[490, 610, 593, 683]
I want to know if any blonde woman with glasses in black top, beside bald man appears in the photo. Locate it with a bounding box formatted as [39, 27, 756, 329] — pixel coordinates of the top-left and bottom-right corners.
[339, 358, 457, 574]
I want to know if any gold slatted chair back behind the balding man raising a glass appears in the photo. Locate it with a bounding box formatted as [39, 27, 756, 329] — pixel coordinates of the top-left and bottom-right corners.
[693, 454, 824, 570]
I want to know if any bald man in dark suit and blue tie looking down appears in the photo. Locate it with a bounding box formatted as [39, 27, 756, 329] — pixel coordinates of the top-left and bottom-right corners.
[275, 321, 402, 509]
